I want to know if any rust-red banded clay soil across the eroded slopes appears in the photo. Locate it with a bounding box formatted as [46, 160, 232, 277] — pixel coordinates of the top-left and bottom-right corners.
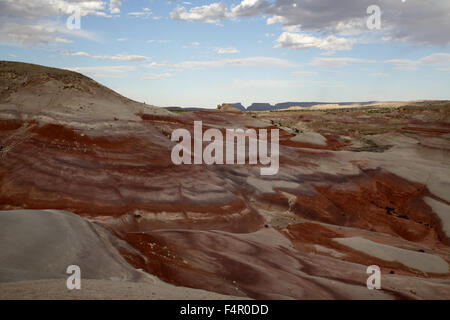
[0, 96, 450, 299]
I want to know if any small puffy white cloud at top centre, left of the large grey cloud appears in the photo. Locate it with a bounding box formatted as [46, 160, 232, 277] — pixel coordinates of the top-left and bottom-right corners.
[170, 2, 228, 23]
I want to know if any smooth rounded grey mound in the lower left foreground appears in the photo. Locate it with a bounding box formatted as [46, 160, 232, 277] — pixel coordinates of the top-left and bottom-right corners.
[0, 210, 139, 282]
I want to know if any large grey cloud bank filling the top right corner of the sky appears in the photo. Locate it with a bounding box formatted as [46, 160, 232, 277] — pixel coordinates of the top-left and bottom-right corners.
[268, 0, 450, 45]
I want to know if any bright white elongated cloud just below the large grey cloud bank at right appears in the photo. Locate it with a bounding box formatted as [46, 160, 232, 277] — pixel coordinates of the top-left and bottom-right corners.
[275, 32, 356, 51]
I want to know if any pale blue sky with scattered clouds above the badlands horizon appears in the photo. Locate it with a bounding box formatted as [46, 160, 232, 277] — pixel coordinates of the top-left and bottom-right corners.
[0, 0, 450, 108]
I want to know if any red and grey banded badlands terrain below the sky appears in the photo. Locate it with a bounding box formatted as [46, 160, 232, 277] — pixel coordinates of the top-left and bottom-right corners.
[0, 62, 450, 299]
